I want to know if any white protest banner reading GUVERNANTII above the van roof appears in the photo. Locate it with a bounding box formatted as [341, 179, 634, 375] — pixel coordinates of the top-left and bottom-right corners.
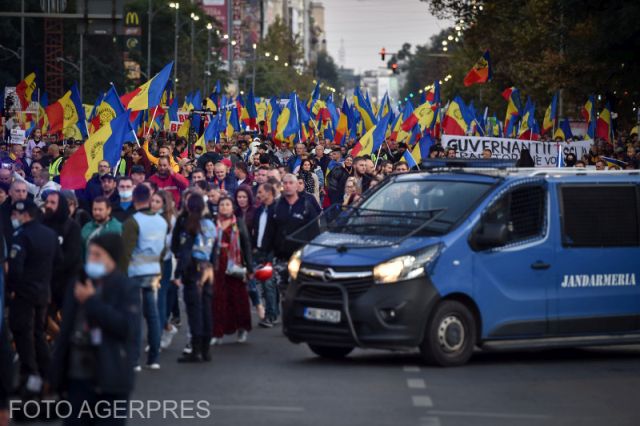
[442, 135, 593, 167]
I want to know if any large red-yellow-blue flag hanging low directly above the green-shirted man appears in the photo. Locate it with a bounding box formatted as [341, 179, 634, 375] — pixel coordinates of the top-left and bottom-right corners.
[60, 112, 132, 189]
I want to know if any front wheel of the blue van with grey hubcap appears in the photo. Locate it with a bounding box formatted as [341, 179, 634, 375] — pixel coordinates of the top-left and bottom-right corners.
[420, 300, 476, 367]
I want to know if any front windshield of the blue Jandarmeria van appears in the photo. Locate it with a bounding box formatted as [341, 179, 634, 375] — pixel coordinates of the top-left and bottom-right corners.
[342, 180, 491, 235]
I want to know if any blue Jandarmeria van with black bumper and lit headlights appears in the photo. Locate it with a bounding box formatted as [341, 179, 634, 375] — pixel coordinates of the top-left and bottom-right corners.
[283, 163, 640, 366]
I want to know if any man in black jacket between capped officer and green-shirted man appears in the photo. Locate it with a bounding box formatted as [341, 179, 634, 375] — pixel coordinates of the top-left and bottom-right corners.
[42, 192, 82, 312]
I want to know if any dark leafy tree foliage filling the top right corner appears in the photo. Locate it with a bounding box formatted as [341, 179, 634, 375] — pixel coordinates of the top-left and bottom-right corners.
[422, 0, 640, 125]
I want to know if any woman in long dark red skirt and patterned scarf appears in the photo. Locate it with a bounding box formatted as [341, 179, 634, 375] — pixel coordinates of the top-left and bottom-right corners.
[211, 197, 253, 345]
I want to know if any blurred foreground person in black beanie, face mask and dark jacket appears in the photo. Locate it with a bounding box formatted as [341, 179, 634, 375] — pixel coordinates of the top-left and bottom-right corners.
[49, 233, 140, 424]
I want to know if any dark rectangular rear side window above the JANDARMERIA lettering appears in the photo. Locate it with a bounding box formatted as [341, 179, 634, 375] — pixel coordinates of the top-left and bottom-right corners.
[560, 185, 640, 247]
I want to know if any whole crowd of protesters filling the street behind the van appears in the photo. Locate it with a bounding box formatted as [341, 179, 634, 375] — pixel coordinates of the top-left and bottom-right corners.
[0, 119, 640, 425]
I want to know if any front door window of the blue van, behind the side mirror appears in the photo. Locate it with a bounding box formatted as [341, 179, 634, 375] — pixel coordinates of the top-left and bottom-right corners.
[471, 185, 546, 250]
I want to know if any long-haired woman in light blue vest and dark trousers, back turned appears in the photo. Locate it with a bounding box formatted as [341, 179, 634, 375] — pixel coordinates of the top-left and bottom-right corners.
[171, 193, 217, 363]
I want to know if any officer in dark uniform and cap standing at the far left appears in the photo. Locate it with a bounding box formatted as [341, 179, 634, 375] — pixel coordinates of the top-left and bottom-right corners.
[7, 200, 60, 398]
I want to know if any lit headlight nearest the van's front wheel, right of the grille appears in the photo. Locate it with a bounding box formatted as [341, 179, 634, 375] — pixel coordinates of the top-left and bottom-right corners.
[373, 245, 440, 284]
